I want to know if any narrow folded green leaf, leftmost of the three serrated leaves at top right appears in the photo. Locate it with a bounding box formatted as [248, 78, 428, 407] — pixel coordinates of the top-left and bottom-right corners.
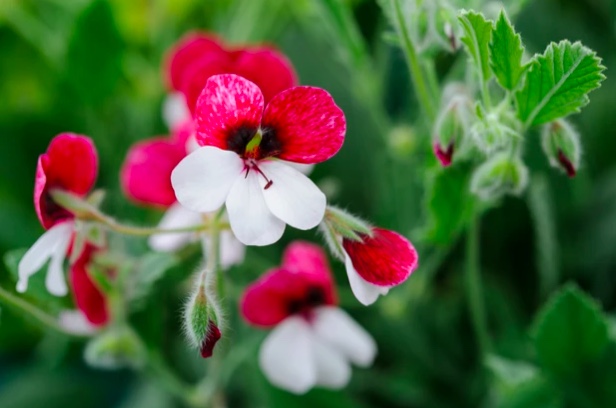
[458, 10, 494, 82]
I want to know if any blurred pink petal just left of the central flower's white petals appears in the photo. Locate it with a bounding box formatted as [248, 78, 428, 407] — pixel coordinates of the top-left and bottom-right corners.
[120, 138, 186, 208]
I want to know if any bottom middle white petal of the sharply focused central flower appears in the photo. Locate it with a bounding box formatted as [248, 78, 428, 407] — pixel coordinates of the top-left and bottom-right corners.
[227, 171, 285, 246]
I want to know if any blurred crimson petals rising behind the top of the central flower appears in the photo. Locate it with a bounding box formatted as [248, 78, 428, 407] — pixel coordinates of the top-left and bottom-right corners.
[167, 33, 297, 113]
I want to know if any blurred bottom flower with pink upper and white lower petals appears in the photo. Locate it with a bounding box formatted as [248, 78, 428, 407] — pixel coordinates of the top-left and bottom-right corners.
[241, 242, 376, 394]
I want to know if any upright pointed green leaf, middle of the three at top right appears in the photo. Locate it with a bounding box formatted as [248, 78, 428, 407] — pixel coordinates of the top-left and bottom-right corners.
[490, 11, 528, 91]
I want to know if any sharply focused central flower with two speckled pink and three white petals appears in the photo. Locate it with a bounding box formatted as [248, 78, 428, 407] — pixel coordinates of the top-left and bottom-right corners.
[171, 75, 346, 245]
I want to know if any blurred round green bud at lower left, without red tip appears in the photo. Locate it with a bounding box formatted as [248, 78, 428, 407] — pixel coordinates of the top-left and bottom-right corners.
[84, 326, 146, 370]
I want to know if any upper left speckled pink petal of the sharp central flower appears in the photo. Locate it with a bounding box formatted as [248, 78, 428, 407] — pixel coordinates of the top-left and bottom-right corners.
[196, 74, 263, 150]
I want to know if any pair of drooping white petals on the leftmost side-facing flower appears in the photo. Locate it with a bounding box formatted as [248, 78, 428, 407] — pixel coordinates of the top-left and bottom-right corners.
[17, 221, 75, 296]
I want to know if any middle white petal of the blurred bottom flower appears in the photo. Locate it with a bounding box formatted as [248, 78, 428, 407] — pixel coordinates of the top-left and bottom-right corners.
[313, 334, 351, 389]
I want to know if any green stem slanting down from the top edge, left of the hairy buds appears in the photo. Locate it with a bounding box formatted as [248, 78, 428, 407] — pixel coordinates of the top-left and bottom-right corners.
[392, 0, 436, 123]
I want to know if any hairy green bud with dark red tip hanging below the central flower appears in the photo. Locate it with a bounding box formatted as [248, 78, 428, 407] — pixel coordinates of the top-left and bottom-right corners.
[184, 278, 222, 358]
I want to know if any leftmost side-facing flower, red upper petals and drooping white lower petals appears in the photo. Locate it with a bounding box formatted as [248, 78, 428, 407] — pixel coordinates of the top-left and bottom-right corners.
[17, 133, 98, 296]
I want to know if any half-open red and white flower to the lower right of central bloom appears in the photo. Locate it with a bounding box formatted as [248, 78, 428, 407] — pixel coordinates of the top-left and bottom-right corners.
[342, 228, 418, 305]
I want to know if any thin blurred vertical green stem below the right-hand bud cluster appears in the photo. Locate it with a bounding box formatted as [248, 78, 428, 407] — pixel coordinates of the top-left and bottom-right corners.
[466, 215, 490, 359]
